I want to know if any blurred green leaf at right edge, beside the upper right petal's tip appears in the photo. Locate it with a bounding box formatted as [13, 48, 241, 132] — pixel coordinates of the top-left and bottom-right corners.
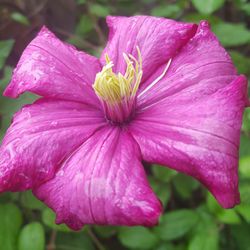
[212, 23, 250, 47]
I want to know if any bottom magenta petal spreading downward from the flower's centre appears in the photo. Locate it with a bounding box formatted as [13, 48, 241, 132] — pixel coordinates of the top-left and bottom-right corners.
[35, 127, 161, 230]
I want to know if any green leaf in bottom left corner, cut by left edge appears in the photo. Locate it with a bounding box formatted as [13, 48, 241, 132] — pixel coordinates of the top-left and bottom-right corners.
[0, 204, 22, 250]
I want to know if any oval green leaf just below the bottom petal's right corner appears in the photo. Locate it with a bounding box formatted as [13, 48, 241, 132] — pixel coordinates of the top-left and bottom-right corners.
[118, 227, 158, 249]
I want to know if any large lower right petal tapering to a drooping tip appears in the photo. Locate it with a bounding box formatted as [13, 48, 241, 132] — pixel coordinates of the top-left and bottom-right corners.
[130, 76, 247, 208]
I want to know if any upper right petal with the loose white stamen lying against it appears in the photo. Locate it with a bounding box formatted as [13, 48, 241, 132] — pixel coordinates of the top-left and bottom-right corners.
[137, 21, 237, 109]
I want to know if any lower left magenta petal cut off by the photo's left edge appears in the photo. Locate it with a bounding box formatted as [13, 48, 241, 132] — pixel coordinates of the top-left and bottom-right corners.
[0, 99, 105, 192]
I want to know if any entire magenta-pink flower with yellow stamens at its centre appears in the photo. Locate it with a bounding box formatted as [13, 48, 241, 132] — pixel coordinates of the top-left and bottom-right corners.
[0, 16, 247, 230]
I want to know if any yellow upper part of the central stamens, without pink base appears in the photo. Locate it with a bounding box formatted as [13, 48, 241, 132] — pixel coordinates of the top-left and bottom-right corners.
[93, 47, 142, 104]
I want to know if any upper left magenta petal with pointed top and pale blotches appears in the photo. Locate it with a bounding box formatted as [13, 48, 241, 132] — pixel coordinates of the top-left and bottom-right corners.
[4, 27, 101, 106]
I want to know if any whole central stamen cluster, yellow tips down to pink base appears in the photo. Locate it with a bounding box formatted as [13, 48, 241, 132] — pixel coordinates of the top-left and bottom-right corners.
[93, 47, 142, 123]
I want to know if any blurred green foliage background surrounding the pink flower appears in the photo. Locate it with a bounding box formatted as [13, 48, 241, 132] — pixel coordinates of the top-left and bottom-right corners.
[0, 0, 250, 250]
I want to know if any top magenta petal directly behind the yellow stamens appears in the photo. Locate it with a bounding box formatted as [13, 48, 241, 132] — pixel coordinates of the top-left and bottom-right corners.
[101, 16, 196, 81]
